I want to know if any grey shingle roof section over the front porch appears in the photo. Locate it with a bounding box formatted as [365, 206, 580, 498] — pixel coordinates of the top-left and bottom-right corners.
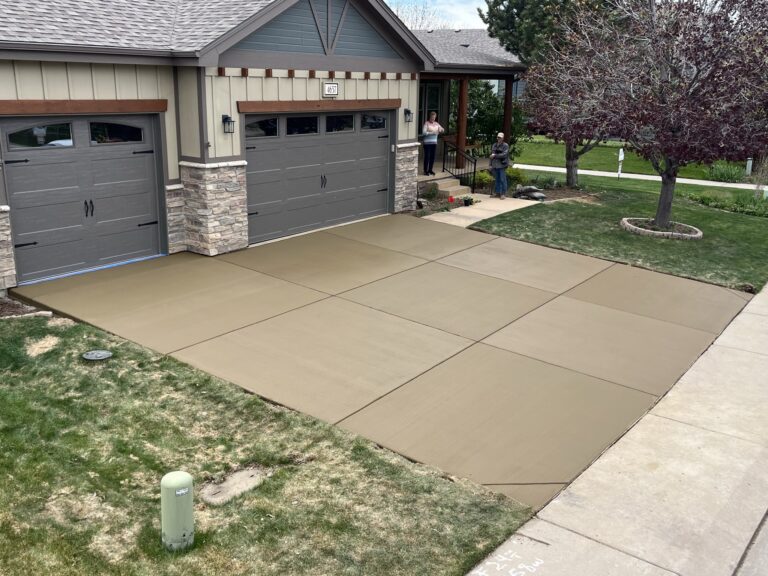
[413, 28, 520, 68]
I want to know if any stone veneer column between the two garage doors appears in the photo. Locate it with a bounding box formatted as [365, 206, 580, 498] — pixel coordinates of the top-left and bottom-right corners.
[178, 160, 248, 256]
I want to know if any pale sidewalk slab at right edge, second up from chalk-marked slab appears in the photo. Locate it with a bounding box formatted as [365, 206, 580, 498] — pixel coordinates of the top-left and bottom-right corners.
[652, 345, 768, 446]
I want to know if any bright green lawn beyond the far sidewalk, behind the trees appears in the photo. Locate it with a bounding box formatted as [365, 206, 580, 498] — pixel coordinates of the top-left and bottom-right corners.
[513, 137, 744, 180]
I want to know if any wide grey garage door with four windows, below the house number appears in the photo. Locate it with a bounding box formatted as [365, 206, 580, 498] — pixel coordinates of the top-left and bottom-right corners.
[245, 112, 391, 243]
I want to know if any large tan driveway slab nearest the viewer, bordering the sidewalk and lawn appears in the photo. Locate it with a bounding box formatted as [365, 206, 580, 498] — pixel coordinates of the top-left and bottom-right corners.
[340, 344, 655, 490]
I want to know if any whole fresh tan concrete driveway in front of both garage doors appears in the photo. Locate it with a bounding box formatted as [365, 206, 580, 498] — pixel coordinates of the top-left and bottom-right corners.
[14, 216, 748, 508]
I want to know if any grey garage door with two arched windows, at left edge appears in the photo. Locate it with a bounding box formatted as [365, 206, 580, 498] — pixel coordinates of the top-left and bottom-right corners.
[0, 116, 160, 282]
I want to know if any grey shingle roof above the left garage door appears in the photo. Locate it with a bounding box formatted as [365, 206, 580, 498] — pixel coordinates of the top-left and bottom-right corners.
[0, 0, 276, 52]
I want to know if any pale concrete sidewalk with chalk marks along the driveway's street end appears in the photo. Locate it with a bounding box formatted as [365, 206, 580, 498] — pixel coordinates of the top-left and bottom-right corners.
[470, 287, 768, 576]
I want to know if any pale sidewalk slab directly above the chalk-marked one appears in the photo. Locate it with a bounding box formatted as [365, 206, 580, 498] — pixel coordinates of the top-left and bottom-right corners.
[539, 415, 768, 576]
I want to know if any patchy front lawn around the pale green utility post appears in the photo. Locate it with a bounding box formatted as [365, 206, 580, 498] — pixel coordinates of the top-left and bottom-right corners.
[0, 318, 530, 576]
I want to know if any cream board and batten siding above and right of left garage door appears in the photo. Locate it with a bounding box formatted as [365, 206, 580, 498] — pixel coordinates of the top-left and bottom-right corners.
[0, 60, 179, 180]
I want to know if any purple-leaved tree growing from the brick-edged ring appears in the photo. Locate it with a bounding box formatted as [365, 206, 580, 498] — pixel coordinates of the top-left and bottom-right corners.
[562, 0, 768, 228]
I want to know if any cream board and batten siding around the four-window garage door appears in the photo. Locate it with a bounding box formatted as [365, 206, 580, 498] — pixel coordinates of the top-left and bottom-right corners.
[204, 68, 419, 158]
